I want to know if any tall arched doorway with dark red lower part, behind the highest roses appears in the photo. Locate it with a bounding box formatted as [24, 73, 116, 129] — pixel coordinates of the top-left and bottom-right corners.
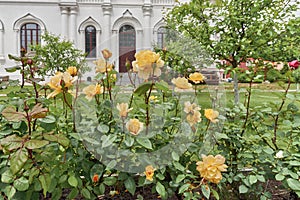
[119, 25, 136, 72]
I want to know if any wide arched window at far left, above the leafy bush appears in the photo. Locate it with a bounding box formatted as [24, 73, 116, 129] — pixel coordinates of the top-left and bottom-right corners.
[21, 23, 41, 52]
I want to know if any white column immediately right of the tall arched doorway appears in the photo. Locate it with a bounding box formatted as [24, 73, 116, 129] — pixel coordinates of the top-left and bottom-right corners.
[143, 2, 152, 49]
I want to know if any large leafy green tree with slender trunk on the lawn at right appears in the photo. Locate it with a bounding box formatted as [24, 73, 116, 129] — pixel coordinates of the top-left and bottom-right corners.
[166, 0, 300, 104]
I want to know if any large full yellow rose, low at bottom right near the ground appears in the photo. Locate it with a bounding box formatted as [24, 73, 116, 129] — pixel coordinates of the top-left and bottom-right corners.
[196, 155, 228, 184]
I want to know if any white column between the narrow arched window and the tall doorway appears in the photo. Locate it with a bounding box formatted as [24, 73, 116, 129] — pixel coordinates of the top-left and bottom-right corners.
[100, 2, 112, 50]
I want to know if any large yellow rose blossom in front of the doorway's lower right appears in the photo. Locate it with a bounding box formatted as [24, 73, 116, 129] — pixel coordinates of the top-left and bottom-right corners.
[132, 50, 165, 80]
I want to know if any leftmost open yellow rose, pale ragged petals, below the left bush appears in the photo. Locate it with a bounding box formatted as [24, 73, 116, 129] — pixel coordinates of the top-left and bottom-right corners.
[47, 72, 77, 99]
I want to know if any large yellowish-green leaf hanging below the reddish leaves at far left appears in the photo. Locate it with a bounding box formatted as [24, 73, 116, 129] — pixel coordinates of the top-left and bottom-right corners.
[10, 148, 28, 174]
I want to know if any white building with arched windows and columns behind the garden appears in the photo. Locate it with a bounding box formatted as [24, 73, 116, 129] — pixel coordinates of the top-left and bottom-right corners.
[0, 0, 175, 79]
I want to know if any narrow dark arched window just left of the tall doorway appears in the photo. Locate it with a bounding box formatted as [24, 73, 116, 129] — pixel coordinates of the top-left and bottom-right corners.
[85, 26, 97, 58]
